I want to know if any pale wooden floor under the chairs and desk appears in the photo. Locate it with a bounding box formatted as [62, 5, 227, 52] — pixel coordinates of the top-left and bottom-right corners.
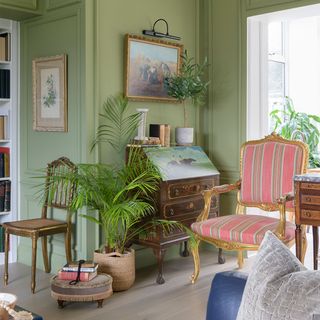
[0, 239, 312, 320]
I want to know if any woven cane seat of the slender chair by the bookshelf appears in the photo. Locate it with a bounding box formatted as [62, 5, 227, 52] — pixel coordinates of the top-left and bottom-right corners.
[6, 218, 68, 231]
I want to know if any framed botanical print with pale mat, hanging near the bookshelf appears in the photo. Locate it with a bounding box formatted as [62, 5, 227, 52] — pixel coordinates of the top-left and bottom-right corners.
[32, 54, 68, 132]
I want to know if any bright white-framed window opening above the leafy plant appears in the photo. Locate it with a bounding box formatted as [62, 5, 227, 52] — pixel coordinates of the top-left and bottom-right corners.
[247, 5, 320, 140]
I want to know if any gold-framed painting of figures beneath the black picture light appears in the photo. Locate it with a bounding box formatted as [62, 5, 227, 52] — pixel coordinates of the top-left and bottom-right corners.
[124, 34, 183, 102]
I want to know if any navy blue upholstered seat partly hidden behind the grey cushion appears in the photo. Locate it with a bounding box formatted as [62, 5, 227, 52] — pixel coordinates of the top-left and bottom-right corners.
[206, 271, 247, 320]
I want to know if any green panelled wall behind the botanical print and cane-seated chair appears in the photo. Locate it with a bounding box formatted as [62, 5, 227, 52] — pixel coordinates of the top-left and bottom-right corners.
[18, 0, 95, 271]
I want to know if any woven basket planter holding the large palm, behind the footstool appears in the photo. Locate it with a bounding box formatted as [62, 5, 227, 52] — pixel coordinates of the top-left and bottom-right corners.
[93, 249, 136, 291]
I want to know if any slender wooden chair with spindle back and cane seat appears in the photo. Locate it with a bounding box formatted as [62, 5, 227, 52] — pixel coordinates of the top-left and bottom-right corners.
[3, 157, 76, 293]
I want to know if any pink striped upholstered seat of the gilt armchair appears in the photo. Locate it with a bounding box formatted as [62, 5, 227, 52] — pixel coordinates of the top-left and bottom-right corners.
[191, 215, 295, 245]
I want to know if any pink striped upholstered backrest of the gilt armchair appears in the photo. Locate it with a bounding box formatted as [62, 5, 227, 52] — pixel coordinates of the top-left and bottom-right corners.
[240, 142, 303, 208]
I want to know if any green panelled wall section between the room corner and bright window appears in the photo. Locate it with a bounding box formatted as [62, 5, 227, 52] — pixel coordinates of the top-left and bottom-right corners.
[204, 0, 320, 213]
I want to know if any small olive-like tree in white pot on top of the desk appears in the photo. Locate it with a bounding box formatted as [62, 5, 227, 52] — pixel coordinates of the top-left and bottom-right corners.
[164, 51, 209, 145]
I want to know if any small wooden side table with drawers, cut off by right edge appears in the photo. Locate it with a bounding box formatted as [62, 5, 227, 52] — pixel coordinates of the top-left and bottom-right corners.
[294, 173, 320, 270]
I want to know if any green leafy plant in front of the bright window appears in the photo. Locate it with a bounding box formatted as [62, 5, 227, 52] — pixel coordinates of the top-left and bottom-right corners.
[270, 97, 320, 168]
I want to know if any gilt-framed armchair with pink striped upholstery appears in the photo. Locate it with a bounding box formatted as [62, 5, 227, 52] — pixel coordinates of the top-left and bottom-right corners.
[191, 133, 309, 283]
